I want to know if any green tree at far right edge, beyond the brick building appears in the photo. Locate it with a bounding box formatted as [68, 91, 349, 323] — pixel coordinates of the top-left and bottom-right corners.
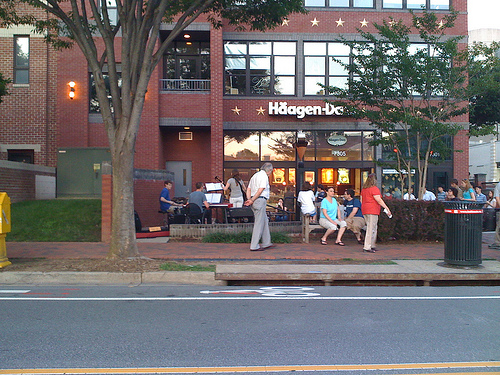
[468, 42, 500, 136]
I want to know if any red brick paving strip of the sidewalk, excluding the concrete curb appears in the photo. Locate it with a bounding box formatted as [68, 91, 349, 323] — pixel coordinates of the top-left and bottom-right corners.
[3, 232, 500, 261]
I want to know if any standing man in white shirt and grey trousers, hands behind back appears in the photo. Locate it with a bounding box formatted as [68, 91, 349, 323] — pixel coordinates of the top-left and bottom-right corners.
[244, 163, 275, 251]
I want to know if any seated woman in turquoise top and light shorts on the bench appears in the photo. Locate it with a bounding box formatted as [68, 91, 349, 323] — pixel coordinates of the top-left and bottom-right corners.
[319, 187, 347, 246]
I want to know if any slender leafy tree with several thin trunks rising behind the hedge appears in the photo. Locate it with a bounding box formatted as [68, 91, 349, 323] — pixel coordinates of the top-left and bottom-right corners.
[328, 11, 467, 198]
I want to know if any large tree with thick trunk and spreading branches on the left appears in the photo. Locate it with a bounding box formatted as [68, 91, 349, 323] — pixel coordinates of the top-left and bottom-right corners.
[0, 0, 305, 258]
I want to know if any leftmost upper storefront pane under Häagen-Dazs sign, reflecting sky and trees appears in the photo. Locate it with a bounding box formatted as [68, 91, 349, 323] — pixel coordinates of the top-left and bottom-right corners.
[224, 131, 259, 161]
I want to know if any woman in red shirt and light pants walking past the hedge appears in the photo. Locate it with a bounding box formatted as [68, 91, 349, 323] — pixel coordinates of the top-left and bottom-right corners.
[361, 173, 392, 253]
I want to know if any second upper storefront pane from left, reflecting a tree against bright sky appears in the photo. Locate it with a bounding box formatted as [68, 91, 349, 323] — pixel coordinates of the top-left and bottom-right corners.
[261, 132, 295, 161]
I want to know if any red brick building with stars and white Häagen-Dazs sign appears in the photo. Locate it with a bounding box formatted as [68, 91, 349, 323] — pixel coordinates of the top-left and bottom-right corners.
[0, 0, 469, 223]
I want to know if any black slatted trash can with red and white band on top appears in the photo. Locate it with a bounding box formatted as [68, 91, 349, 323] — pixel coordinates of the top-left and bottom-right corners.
[443, 201, 483, 266]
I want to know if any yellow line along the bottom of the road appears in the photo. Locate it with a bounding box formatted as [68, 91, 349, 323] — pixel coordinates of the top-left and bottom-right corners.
[0, 361, 500, 375]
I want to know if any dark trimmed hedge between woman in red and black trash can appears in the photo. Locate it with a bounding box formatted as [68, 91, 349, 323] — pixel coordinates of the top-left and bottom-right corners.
[378, 200, 444, 242]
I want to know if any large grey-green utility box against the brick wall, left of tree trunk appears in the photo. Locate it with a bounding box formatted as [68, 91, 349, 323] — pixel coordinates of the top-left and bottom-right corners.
[57, 147, 111, 198]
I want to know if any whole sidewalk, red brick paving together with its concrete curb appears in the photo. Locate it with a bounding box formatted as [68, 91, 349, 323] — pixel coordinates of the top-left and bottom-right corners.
[0, 232, 500, 286]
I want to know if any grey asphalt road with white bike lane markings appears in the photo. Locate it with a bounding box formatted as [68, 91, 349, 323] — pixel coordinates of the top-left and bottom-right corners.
[0, 286, 500, 374]
